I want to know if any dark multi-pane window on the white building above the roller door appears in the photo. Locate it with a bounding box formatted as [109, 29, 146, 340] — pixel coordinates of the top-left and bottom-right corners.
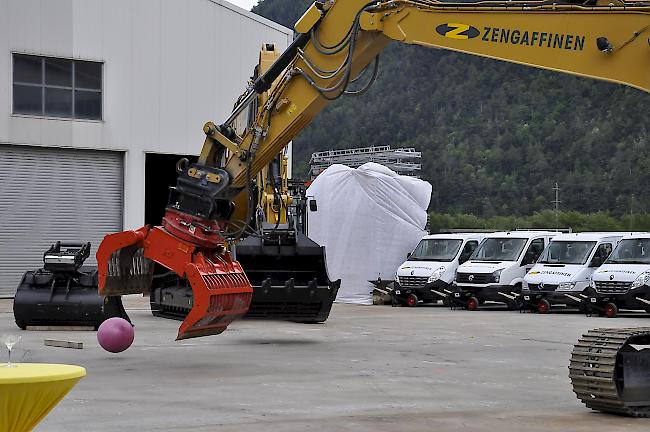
[13, 54, 102, 120]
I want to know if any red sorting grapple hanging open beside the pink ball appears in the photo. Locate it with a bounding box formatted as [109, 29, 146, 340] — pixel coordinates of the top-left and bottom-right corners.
[97, 226, 253, 340]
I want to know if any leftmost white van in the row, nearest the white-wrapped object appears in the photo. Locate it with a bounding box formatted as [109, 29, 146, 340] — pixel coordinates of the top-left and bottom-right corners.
[392, 233, 485, 306]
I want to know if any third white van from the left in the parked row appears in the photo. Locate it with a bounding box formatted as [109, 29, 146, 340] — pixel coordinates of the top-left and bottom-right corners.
[521, 232, 623, 313]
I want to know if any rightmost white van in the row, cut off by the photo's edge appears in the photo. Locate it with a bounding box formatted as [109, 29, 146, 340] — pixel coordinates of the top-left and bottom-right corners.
[589, 233, 650, 318]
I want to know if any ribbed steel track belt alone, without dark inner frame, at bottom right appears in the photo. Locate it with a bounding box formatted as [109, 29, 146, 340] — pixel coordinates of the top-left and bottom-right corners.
[569, 327, 650, 417]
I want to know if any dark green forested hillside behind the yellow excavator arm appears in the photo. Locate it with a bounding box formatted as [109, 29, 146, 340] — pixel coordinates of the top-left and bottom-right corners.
[253, 0, 650, 217]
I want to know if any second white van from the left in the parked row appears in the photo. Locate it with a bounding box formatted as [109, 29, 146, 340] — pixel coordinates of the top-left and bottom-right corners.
[453, 231, 558, 310]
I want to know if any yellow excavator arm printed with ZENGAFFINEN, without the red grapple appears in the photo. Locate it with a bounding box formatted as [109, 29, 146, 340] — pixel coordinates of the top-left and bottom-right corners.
[199, 0, 650, 228]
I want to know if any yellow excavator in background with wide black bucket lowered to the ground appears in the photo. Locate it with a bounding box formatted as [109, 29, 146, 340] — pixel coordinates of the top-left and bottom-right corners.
[147, 45, 341, 323]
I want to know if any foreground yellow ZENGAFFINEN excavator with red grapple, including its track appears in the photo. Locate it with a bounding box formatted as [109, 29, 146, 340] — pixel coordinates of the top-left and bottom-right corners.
[97, 0, 650, 416]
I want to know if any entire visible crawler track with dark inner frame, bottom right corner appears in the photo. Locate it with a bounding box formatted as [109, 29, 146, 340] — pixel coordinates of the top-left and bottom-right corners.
[569, 328, 650, 417]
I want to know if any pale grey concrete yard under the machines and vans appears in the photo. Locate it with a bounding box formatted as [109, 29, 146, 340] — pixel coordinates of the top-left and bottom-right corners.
[0, 297, 650, 432]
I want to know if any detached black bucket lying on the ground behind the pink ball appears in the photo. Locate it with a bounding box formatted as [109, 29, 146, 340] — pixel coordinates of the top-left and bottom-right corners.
[14, 242, 130, 329]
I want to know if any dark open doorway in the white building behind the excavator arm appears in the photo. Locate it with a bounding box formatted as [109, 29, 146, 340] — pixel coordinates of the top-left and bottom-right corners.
[144, 153, 197, 226]
